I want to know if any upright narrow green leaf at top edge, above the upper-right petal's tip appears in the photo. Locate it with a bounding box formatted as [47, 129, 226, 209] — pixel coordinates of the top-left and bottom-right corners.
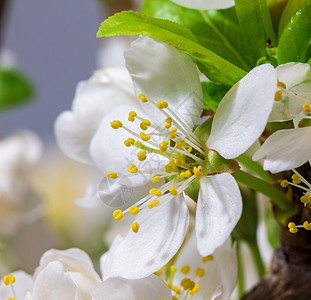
[235, 0, 276, 59]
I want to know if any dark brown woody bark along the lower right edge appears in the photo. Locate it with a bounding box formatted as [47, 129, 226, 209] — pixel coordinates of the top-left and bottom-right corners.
[242, 164, 311, 300]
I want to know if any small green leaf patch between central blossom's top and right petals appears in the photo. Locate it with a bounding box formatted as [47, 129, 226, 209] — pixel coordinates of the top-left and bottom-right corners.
[201, 81, 229, 112]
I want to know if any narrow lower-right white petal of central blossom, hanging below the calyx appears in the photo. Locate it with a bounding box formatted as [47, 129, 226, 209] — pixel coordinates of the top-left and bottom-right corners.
[195, 173, 242, 256]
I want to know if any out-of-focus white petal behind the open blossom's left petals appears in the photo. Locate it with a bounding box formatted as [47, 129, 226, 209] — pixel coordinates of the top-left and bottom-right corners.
[55, 68, 138, 164]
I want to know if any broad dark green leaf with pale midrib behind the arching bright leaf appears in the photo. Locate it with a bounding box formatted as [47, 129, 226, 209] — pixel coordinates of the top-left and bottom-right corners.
[143, 0, 256, 70]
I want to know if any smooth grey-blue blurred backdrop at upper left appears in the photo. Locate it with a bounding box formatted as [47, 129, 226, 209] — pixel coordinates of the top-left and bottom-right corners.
[0, 0, 103, 139]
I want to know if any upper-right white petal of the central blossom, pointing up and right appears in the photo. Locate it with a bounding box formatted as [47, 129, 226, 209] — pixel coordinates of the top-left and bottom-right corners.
[206, 64, 277, 159]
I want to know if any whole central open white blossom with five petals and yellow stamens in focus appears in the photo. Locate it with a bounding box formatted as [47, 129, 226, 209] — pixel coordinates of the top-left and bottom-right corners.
[80, 38, 277, 279]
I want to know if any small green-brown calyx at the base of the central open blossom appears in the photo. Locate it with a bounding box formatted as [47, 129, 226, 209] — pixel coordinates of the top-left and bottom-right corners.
[202, 150, 240, 175]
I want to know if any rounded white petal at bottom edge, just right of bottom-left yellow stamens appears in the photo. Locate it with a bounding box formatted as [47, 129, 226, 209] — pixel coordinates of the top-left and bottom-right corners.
[32, 261, 82, 300]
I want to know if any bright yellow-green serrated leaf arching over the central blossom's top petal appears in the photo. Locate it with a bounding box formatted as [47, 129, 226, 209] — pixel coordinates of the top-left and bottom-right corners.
[97, 11, 246, 85]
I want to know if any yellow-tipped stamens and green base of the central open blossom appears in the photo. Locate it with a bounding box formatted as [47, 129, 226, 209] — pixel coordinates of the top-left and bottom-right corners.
[106, 94, 236, 233]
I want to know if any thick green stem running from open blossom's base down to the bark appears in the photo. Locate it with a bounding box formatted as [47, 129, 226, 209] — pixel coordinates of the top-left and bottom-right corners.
[232, 170, 293, 212]
